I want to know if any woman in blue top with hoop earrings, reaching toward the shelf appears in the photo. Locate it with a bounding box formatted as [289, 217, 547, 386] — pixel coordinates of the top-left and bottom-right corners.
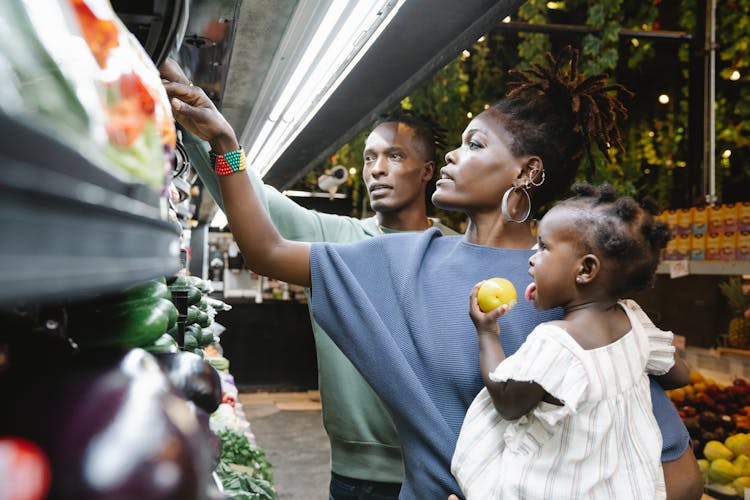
[166, 46, 701, 500]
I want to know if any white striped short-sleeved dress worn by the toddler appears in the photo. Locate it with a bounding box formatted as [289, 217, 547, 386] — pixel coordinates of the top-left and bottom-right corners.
[451, 300, 674, 500]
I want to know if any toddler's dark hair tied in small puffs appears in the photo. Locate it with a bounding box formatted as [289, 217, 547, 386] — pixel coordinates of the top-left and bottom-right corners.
[559, 183, 671, 296]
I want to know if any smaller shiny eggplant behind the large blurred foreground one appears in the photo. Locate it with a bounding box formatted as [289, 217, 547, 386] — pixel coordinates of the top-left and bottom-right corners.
[153, 351, 221, 413]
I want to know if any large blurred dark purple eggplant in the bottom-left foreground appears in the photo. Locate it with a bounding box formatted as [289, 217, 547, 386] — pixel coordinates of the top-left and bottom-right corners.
[0, 349, 213, 500]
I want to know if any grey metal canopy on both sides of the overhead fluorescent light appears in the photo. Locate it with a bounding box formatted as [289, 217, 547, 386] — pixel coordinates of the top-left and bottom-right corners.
[217, 0, 523, 189]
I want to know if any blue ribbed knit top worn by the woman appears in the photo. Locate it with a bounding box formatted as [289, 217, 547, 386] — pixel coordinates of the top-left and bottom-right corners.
[310, 229, 688, 500]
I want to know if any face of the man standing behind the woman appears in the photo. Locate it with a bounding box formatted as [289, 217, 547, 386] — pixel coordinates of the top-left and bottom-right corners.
[362, 122, 435, 212]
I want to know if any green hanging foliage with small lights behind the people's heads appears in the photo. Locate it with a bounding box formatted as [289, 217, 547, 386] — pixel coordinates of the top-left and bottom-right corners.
[302, 0, 750, 220]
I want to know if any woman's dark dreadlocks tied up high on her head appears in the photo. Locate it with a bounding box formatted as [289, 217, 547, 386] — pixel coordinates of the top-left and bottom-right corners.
[492, 46, 633, 207]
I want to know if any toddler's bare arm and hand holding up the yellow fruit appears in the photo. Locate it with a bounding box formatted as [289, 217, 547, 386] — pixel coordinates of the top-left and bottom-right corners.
[469, 282, 547, 420]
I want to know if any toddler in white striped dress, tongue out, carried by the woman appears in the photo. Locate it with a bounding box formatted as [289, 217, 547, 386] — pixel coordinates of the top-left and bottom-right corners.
[451, 184, 690, 500]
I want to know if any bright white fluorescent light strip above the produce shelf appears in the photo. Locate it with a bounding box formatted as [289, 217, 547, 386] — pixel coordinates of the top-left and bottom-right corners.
[242, 0, 405, 176]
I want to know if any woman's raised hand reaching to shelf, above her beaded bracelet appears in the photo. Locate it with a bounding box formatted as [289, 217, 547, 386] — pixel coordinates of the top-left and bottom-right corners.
[159, 59, 239, 154]
